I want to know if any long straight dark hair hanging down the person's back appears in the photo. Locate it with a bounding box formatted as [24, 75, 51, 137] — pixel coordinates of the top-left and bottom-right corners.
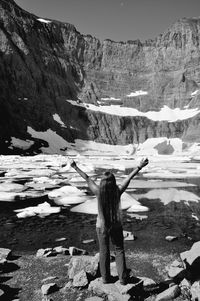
[98, 171, 119, 227]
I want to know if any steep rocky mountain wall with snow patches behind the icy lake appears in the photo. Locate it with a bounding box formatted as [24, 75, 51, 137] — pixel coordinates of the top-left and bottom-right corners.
[0, 0, 200, 154]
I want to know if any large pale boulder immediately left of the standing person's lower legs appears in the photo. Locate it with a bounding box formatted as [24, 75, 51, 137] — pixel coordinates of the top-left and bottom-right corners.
[68, 255, 99, 279]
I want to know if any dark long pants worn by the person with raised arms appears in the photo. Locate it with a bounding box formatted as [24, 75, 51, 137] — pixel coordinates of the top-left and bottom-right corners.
[97, 224, 126, 282]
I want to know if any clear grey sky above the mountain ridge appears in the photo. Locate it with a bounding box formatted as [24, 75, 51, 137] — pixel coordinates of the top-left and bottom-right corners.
[15, 0, 200, 41]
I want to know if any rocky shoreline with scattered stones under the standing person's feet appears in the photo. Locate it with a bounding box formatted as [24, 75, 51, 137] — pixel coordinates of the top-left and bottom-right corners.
[0, 241, 200, 301]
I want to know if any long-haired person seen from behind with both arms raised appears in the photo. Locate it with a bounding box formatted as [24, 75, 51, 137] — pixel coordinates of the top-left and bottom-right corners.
[71, 158, 149, 285]
